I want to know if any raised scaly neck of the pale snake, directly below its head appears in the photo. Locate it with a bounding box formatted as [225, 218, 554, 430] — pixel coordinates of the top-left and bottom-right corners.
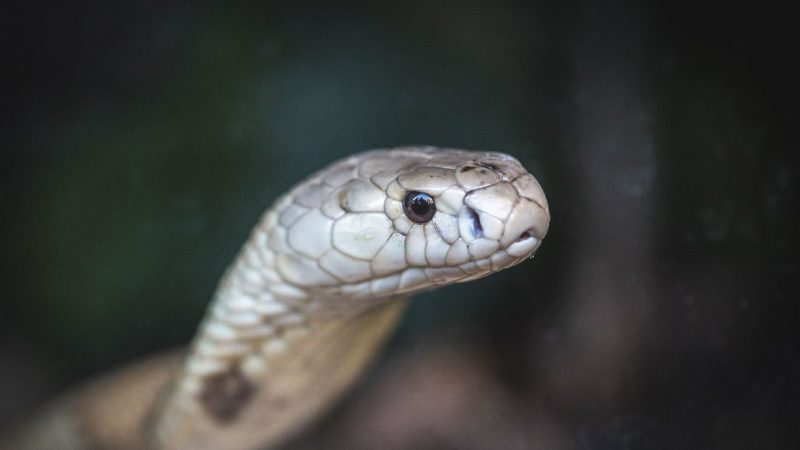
[148, 223, 406, 449]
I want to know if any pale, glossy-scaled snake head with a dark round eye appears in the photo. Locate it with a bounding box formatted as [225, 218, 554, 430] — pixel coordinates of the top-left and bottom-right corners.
[260, 147, 550, 308]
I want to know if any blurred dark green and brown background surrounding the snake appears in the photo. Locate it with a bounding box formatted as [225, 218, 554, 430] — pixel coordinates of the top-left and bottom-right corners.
[0, 0, 800, 449]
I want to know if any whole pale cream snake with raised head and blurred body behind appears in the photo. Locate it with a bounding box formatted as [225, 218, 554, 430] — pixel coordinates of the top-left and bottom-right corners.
[1, 147, 550, 450]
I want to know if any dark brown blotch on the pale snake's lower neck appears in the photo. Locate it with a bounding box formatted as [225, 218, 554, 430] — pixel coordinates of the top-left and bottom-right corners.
[199, 365, 256, 423]
